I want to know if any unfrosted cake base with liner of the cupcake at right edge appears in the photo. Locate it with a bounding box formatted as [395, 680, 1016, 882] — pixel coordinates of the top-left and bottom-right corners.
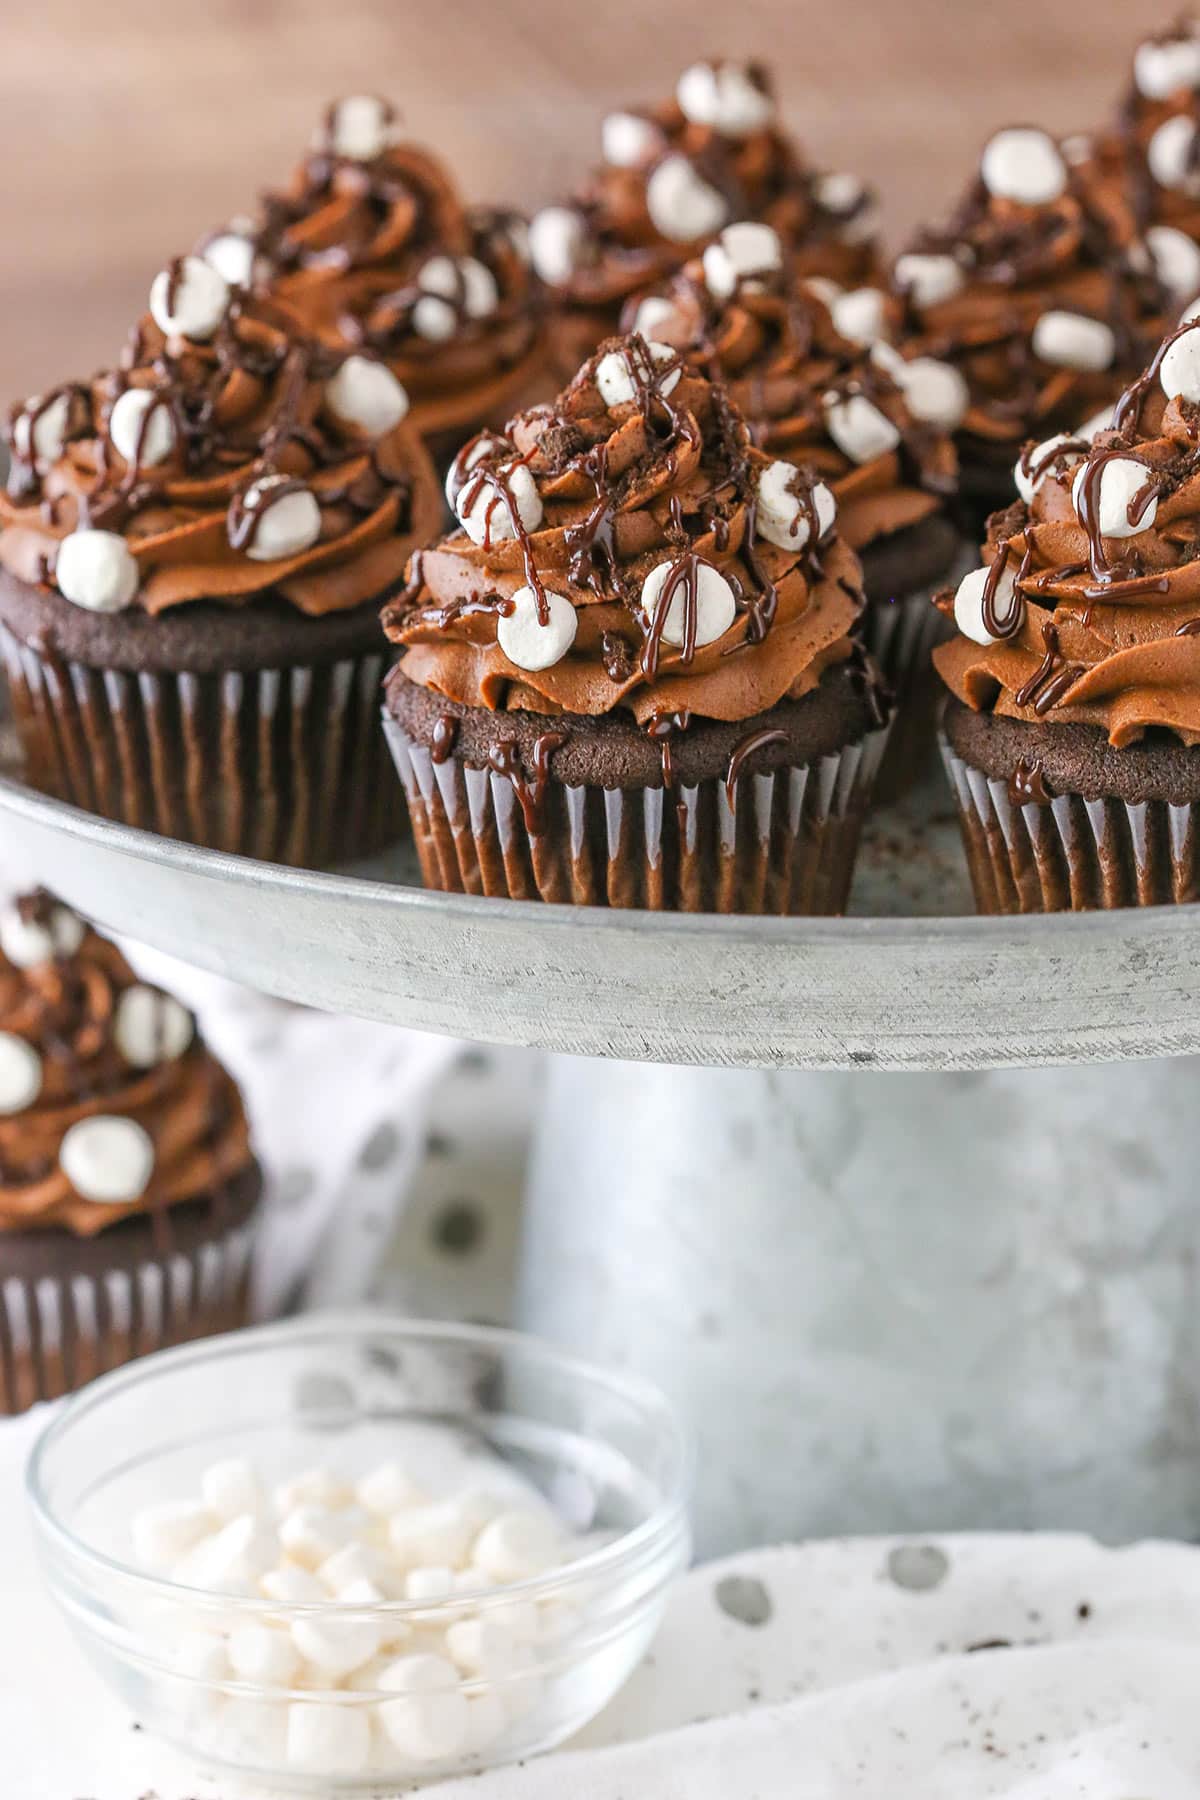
[943, 698, 1200, 913]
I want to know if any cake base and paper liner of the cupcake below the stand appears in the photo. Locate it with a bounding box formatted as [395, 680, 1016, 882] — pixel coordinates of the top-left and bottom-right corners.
[0, 1168, 263, 1413]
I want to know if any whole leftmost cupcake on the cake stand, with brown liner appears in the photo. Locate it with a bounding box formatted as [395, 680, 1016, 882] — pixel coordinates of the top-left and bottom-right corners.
[0, 270, 441, 866]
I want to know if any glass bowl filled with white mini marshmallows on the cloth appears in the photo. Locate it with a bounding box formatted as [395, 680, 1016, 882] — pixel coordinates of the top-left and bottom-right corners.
[29, 1316, 691, 1795]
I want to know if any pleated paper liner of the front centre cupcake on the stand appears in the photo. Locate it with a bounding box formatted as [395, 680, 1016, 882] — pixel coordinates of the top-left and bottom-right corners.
[385, 718, 887, 914]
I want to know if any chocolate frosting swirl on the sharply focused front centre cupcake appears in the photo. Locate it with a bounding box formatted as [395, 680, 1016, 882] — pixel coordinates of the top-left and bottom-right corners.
[385, 335, 874, 724]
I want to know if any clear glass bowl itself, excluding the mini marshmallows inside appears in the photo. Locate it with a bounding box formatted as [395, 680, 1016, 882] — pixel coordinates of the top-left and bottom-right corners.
[29, 1316, 691, 1795]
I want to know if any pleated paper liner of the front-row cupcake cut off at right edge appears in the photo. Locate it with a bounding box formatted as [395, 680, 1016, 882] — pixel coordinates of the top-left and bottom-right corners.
[941, 738, 1200, 913]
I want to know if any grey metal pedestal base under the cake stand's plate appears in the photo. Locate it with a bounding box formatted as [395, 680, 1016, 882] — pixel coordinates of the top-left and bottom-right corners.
[518, 1058, 1200, 1555]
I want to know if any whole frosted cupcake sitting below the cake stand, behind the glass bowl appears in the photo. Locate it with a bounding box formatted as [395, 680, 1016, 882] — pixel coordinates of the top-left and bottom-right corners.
[0, 893, 261, 1413]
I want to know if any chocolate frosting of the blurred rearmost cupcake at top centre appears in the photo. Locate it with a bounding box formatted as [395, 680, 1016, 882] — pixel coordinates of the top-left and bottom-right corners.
[533, 63, 878, 380]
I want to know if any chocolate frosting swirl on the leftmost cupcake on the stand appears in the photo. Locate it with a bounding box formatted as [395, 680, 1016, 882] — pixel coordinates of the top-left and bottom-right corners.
[0, 290, 441, 616]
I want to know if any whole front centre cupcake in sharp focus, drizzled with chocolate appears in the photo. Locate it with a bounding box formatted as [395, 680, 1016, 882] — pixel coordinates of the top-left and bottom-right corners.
[385, 335, 885, 913]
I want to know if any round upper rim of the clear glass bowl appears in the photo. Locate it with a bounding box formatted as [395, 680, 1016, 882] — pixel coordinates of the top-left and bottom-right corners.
[25, 1310, 694, 1620]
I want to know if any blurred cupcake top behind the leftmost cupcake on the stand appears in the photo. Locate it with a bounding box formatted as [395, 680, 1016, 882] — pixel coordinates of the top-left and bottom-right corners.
[198, 95, 547, 461]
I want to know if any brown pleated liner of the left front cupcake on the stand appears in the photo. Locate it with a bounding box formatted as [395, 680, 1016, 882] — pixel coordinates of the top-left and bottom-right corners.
[0, 625, 403, 868]
